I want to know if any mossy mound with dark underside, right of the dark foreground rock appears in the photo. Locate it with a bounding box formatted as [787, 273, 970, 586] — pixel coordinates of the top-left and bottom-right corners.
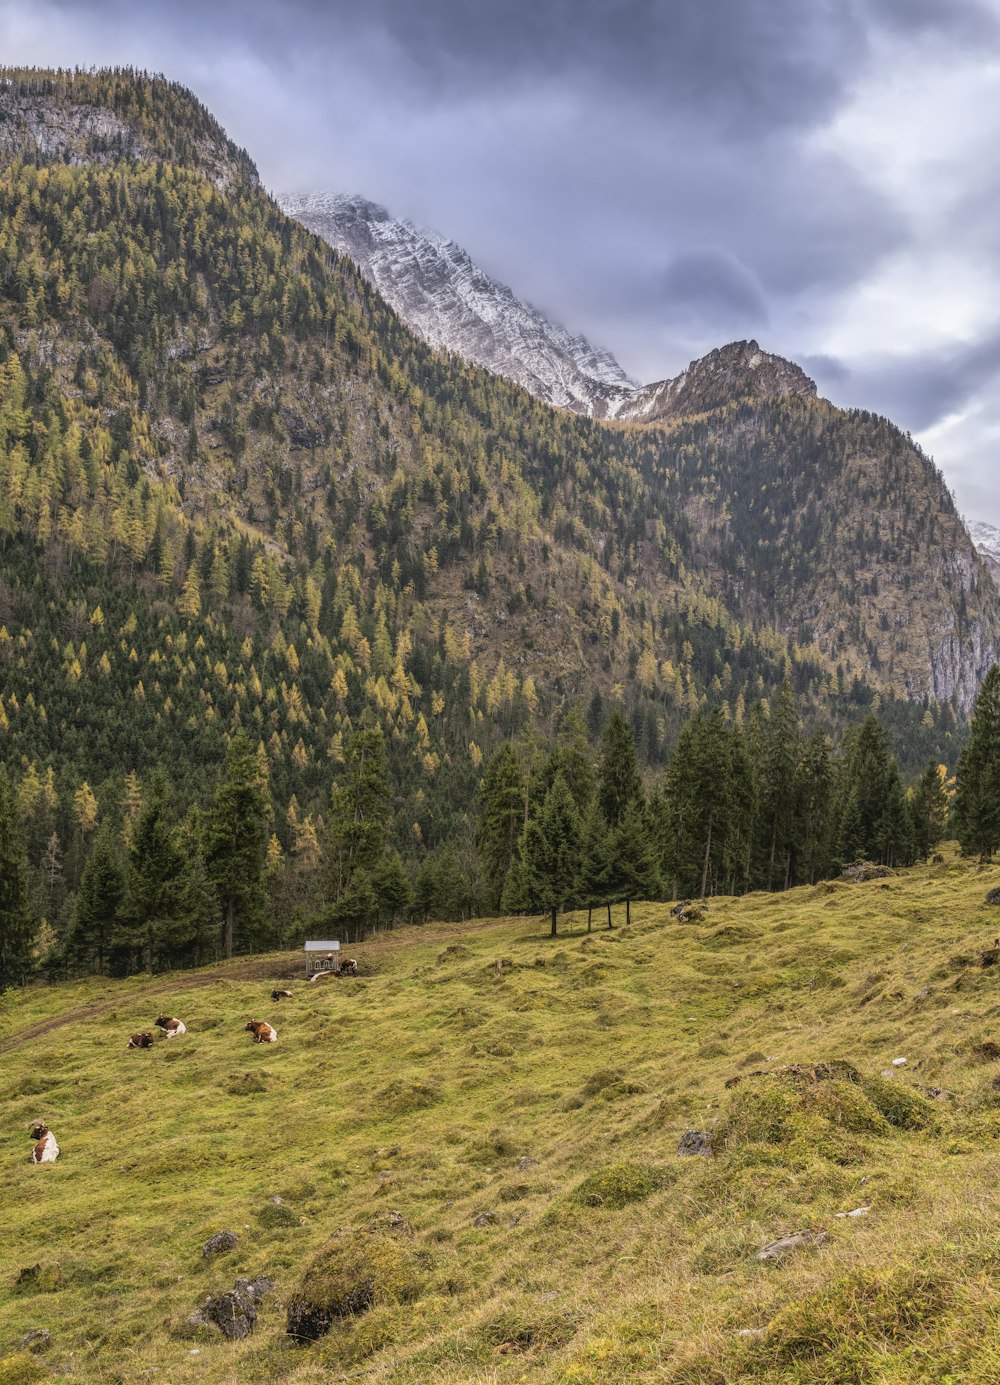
[287, 1231, 420, 1342]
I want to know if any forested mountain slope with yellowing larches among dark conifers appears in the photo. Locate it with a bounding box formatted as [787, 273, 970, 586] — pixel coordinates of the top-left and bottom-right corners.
[0, 71, 996, 869]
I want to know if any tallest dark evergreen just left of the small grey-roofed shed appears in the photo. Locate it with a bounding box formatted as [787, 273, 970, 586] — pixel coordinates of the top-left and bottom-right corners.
[205, 731, 270, 957]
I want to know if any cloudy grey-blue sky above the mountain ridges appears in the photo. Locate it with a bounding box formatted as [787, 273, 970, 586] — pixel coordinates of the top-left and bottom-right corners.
[0, 0, 1000, 525]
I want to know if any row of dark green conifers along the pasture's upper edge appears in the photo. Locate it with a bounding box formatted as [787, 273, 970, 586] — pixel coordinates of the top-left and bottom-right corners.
[0, 665, 1000, 988]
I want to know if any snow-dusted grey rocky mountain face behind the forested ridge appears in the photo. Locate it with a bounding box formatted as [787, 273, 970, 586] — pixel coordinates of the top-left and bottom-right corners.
[278, 193, 633, 414]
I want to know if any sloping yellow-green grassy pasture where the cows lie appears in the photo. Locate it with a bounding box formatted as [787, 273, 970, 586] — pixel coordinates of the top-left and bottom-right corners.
[7, 856, 1000, 1385]
